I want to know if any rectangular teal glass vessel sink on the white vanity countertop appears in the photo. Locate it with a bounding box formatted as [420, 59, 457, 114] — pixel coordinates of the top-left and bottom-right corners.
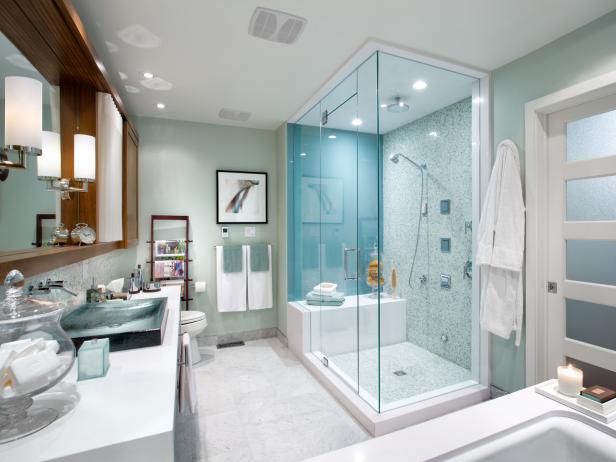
[60, 298, 167, 351]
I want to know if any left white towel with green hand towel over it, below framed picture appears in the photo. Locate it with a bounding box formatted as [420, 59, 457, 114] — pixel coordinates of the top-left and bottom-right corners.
[216, 245, 247, 313]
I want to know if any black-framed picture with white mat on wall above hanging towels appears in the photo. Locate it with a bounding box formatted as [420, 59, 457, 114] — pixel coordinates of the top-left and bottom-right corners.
[216, 170, 267, 224]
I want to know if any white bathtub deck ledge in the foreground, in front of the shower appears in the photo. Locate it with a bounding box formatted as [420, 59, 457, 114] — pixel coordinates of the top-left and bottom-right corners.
[306, 387, 616, 462]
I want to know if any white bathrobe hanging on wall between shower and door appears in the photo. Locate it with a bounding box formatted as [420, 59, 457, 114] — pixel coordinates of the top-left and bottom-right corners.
[476, 140, 525, 346]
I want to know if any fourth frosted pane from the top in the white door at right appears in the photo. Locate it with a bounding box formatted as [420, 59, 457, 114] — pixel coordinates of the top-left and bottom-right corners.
[566, 299, 616, 350]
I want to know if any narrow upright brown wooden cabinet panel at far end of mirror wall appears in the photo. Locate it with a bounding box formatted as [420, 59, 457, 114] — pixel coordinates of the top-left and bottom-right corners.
[122, 120, 139, 248]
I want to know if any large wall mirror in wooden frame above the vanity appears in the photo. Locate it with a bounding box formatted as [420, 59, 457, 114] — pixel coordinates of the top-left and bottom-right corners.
[0, 30, 61, 255]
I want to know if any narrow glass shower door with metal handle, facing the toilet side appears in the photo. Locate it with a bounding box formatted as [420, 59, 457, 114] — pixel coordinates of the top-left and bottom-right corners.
[318, 74, 359, 391]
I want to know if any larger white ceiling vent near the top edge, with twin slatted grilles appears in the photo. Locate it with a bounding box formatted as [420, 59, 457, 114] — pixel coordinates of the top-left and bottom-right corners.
[248, 6, 307, 45]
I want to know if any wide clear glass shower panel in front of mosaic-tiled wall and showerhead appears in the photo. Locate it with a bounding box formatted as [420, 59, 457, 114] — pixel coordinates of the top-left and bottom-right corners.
[379, 53, 476, 411]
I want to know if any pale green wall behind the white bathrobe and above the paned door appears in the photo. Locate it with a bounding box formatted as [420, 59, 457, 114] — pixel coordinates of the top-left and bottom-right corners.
[491, 12, 616, 391]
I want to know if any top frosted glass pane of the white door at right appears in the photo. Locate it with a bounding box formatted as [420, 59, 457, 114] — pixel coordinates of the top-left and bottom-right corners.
[567, 111, 616, 161]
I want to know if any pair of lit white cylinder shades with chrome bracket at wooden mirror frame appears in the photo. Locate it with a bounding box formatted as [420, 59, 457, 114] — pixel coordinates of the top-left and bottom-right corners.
[37, 132, 96, 200]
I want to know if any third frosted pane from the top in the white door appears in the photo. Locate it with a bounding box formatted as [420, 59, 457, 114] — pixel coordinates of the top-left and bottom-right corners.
[567, 240, 616, 286]
